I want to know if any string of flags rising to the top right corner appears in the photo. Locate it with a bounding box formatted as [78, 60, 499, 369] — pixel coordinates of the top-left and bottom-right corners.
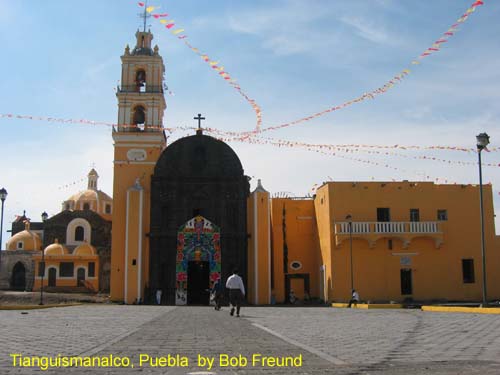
[252, 0, 484, 134]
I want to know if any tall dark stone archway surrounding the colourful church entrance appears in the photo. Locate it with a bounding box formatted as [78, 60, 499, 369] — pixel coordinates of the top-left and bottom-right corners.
[149, 134, 250, 305]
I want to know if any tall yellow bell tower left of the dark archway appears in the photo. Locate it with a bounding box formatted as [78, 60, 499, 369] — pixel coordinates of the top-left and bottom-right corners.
[111, 28, 166, 303]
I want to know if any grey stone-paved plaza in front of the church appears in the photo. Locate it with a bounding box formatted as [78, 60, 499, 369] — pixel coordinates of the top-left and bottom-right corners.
[0, 305, 500, 374]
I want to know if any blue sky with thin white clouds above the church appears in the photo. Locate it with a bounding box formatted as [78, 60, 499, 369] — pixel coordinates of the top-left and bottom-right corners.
[0, 0, 500, 244]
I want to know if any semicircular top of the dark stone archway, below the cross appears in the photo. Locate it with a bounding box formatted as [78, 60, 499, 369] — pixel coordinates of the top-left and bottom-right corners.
[154, 134, 243, 178]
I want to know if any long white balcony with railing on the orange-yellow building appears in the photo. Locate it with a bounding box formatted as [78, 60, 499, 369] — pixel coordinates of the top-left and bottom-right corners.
[334, 221, 443, 248]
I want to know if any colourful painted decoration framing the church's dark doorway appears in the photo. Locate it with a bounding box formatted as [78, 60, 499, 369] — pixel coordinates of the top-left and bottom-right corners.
[175, 215, 221, 305]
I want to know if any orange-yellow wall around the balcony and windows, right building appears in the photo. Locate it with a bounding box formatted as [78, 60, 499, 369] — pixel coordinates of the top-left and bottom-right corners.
[322, 182, 500, 301]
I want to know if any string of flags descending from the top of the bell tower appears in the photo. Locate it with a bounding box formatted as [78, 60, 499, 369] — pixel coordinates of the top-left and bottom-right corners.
[138, 2, 262, 132]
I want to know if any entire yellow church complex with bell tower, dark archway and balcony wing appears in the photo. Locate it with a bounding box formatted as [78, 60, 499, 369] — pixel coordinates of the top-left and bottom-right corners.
[111, 31, 500, 305]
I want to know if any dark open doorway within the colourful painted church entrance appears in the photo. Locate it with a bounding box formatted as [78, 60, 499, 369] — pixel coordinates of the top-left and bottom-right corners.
[187, 261, 210, 305]
